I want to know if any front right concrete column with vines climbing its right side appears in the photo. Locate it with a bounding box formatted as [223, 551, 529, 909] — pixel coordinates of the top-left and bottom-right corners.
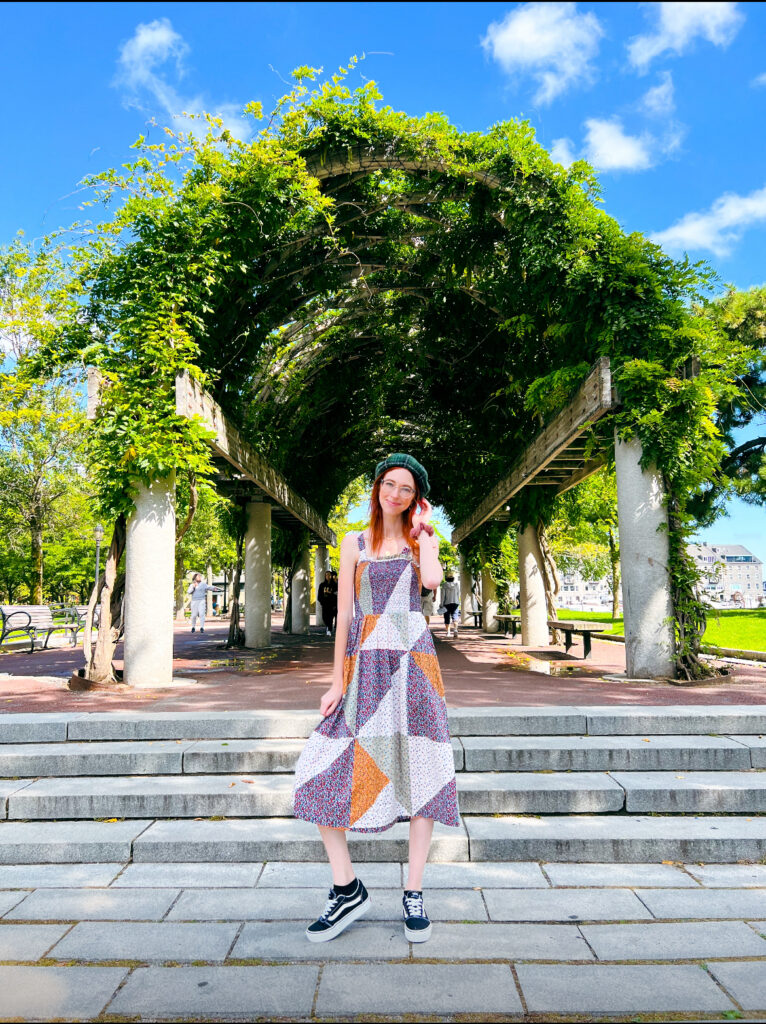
[614, 438, 675, 679]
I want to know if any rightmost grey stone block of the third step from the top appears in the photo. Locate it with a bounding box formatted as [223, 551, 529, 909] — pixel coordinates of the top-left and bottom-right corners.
[614, 771, 766, 816]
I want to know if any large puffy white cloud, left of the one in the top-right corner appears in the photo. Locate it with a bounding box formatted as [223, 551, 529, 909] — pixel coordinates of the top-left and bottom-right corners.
[481, 0, 603, 103]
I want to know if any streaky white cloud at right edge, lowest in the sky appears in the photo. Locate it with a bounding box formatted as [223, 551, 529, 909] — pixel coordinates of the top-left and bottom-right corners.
[652, 185, 766, 257]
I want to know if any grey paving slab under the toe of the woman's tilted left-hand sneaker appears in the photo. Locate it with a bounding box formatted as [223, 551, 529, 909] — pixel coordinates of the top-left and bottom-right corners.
[230, 919, 401, 958]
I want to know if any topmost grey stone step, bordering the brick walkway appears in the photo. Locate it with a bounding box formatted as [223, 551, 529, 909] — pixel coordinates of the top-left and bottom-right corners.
[0, 705, 766, 743]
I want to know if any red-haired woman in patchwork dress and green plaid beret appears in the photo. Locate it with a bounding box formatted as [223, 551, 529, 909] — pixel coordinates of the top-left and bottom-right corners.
[293, 453, 460, 942]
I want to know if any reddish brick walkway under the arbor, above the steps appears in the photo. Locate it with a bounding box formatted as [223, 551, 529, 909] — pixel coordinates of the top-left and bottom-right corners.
[0, 621, 766, 712]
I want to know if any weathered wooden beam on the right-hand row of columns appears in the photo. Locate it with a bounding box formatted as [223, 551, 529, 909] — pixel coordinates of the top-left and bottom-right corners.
[452, 356, 615, 544]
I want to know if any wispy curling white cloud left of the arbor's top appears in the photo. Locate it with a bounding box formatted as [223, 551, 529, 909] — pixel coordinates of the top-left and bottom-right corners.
[116, 17, 252, 139]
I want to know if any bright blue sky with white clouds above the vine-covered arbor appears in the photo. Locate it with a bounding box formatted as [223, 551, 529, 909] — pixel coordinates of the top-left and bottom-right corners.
[0, 2, 766, 561]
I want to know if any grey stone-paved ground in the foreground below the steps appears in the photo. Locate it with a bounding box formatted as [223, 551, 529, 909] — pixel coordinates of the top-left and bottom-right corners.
[0, 861, 766, 1020]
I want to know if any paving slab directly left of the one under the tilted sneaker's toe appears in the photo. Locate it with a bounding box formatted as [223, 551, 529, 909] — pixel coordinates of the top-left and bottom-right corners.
[49, 921, 239, 962]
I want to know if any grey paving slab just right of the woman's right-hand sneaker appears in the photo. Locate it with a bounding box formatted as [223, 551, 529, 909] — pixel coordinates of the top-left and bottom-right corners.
[483, 889, 651, 921]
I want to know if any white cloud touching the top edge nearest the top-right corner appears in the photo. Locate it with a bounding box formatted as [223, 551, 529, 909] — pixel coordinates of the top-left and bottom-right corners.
[628, 0, 744, 71]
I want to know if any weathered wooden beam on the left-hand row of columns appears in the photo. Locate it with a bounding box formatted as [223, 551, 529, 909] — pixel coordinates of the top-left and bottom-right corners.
[175, 372, 338, 547]
